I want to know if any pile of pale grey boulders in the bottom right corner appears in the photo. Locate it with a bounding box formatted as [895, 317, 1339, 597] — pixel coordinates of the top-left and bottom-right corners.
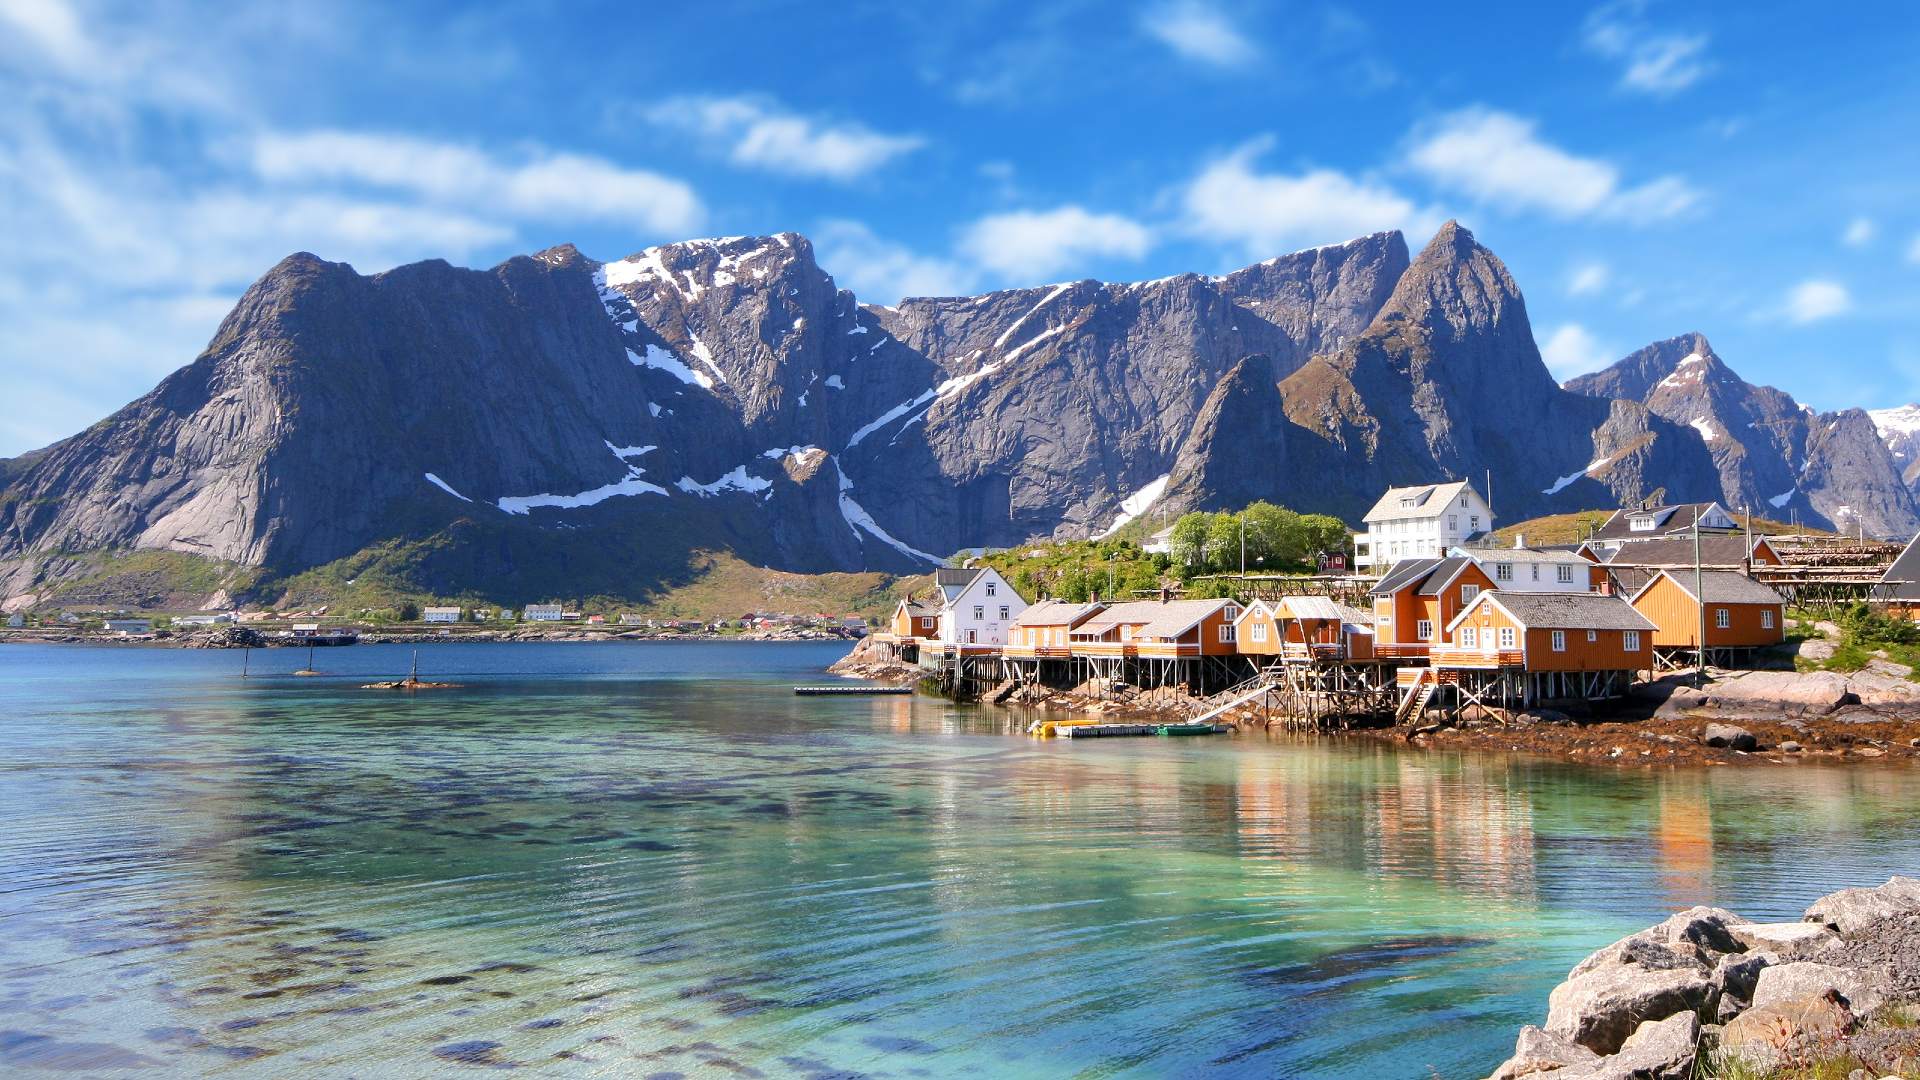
[1488, 876, 1920, 1080]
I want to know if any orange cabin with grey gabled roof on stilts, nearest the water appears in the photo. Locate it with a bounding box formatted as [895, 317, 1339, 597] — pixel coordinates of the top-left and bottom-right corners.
[1432, 590, 1653, 673]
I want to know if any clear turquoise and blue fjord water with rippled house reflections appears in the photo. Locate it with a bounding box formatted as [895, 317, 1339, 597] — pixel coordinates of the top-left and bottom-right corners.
[11, 644, 1920, 1078]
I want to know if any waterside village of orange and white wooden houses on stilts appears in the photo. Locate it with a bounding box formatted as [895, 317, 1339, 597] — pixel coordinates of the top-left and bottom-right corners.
[841, 480, 1920, 751]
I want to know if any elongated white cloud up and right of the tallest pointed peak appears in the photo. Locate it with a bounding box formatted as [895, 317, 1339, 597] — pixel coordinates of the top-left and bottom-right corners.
[1407, 108, 1699, 223]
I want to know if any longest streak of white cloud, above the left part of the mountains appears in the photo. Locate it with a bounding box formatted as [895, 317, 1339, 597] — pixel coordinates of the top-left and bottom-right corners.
[250, 131, 705, 233]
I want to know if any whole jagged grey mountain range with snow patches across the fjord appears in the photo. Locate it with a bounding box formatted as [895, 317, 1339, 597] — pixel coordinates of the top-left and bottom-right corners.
[0, 223, 1912, 603]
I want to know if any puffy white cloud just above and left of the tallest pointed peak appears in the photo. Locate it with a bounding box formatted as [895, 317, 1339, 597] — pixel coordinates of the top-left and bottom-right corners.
[1181, 140, 1442, 258]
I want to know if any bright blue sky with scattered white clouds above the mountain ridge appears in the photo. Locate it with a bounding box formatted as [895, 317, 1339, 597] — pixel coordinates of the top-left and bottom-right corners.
[0, 0, 1920, 455]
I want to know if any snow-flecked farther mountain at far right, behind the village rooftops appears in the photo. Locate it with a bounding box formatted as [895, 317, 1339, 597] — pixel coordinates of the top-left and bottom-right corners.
[1567, 332, 1920, 536]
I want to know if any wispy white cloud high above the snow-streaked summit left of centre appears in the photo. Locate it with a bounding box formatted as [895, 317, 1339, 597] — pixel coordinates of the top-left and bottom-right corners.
[647, 96, 927, 181]
